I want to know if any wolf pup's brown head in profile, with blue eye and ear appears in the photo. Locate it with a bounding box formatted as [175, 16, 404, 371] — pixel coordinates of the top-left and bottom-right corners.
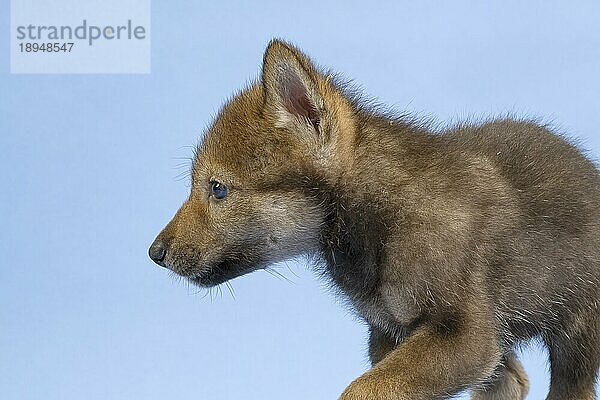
[149, 40, 355, 286]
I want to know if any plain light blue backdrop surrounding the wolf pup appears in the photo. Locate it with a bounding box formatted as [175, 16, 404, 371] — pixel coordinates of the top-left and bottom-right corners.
[0, 0, 600, 400]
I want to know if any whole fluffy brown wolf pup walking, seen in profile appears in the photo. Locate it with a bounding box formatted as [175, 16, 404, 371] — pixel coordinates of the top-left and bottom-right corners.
[149, 40, 600, 400]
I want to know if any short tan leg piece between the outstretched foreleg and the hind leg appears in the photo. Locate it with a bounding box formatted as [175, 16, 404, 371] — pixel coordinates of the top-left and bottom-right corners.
[471, 353, 529, 400]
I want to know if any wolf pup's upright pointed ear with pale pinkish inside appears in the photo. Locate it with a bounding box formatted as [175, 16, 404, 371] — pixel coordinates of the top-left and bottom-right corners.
[262, 40, 324, 132]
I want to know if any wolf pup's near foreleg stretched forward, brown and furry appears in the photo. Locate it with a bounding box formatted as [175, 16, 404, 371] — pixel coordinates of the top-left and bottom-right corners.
[340, 316, 502, 400]
